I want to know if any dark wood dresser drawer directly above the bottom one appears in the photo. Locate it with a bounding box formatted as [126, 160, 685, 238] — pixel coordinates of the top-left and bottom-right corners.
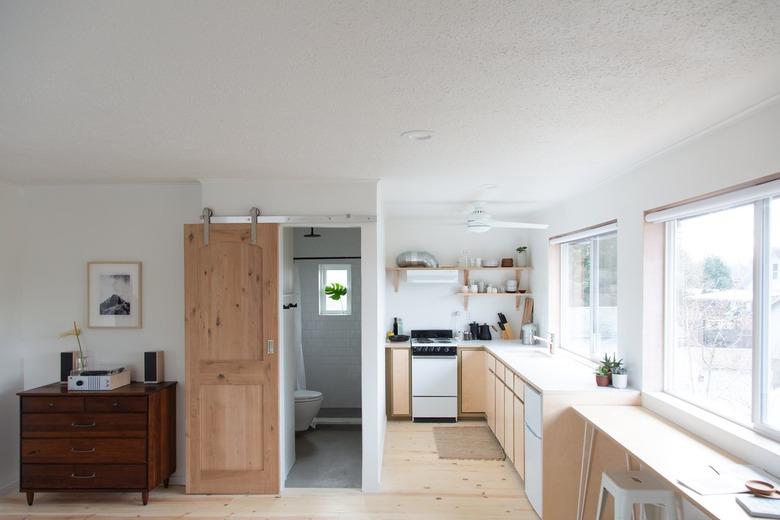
[22, 438, 146, 464]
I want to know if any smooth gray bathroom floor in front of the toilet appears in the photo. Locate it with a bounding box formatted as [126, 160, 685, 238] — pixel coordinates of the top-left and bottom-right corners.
[285, 425, 362, 488]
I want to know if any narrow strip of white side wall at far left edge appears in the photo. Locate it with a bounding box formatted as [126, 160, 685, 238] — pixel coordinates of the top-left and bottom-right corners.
[0, 183, 25, 494]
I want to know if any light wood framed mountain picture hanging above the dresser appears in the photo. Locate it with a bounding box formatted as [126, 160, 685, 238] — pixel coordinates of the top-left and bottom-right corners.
[87, 262, 142, 329]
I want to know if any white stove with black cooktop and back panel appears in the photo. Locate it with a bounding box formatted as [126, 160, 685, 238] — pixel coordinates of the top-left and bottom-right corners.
[411, 330, 458, 422]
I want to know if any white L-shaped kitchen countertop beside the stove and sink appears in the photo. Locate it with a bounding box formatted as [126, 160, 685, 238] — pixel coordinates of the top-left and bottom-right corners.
[387, 339, 636, 393]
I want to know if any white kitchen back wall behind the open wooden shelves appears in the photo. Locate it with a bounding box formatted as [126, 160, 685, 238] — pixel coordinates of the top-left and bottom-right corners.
[383, 220, 535, 335]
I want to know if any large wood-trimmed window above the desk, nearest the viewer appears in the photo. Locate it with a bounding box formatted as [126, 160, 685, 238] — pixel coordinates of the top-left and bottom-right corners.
[647, 183, 780, 438]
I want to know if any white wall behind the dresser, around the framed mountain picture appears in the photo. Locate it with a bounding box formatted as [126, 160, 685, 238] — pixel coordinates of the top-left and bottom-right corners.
[11, 185, 200, 482]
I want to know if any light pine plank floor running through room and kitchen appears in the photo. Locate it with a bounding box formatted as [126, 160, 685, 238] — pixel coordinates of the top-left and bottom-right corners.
[0, 422, 538, 520]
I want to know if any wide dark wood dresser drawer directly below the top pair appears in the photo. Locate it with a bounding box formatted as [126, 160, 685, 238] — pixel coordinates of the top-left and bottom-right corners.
[22, 413, 146, 438]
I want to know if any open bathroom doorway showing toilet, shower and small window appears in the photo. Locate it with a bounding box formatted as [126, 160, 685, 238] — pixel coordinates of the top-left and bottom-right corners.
[282, 226, 362, 489]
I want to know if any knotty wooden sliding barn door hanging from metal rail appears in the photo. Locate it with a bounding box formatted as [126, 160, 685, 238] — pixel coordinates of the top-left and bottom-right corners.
[184, 224, 279, 494]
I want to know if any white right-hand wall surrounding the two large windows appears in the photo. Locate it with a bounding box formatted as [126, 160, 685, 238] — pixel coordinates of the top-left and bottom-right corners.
[531, 98, 780, 482]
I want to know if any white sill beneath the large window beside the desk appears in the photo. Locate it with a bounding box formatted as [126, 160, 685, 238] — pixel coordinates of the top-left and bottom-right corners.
[642, 392, 780, 475]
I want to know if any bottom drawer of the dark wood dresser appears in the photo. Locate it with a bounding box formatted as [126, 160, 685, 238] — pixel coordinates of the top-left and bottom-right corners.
[20, 464, 146, 491]
